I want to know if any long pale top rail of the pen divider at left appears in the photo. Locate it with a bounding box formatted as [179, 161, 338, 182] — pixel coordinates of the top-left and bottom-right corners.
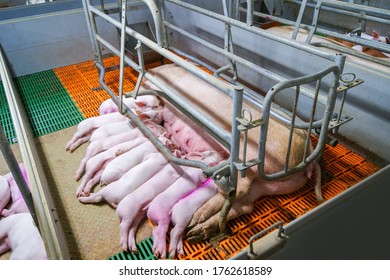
[0, 43, 69, 259]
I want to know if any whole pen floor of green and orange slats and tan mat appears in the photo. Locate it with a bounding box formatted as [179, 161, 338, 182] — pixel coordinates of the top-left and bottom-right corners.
[0, 55, 380, 260]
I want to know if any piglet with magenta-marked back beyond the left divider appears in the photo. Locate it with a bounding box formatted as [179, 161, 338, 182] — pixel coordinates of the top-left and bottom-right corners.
[1, 163, 30, 217]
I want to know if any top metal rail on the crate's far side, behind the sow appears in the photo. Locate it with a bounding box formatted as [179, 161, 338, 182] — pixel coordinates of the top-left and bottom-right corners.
[164, 0, 335, 61]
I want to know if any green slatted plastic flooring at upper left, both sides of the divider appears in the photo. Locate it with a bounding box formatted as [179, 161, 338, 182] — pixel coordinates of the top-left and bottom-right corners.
[0, 70, 83, 144]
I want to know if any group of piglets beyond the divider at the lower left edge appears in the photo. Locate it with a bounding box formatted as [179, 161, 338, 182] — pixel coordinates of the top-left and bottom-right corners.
[0, 163, 47, 260]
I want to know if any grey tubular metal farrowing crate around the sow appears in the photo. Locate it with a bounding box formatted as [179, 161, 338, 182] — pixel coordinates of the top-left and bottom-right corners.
[83, 0, 345, 230]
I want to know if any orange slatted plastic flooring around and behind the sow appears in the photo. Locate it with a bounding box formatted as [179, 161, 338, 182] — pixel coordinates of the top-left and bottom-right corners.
[55, 57, 380, 260]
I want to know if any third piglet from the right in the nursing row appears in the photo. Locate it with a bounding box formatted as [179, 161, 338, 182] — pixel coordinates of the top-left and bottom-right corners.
[116, 163, 183, 253]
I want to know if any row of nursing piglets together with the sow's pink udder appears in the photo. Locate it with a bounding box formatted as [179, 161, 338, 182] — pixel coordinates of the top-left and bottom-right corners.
[67, 92, 229, 258]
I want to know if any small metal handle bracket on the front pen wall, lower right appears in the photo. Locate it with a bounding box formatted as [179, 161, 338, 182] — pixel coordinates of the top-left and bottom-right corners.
[248, 221, 288, 259]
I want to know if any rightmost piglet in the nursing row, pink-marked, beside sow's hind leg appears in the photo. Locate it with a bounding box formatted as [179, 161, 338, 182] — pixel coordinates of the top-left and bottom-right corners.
[169, 178, 219, 258]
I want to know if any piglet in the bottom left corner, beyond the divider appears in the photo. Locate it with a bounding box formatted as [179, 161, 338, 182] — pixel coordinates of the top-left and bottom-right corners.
[0, 213, 47, 260]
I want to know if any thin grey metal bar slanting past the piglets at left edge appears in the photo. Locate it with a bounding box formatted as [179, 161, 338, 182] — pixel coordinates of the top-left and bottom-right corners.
[0, 124, 39, 226]
